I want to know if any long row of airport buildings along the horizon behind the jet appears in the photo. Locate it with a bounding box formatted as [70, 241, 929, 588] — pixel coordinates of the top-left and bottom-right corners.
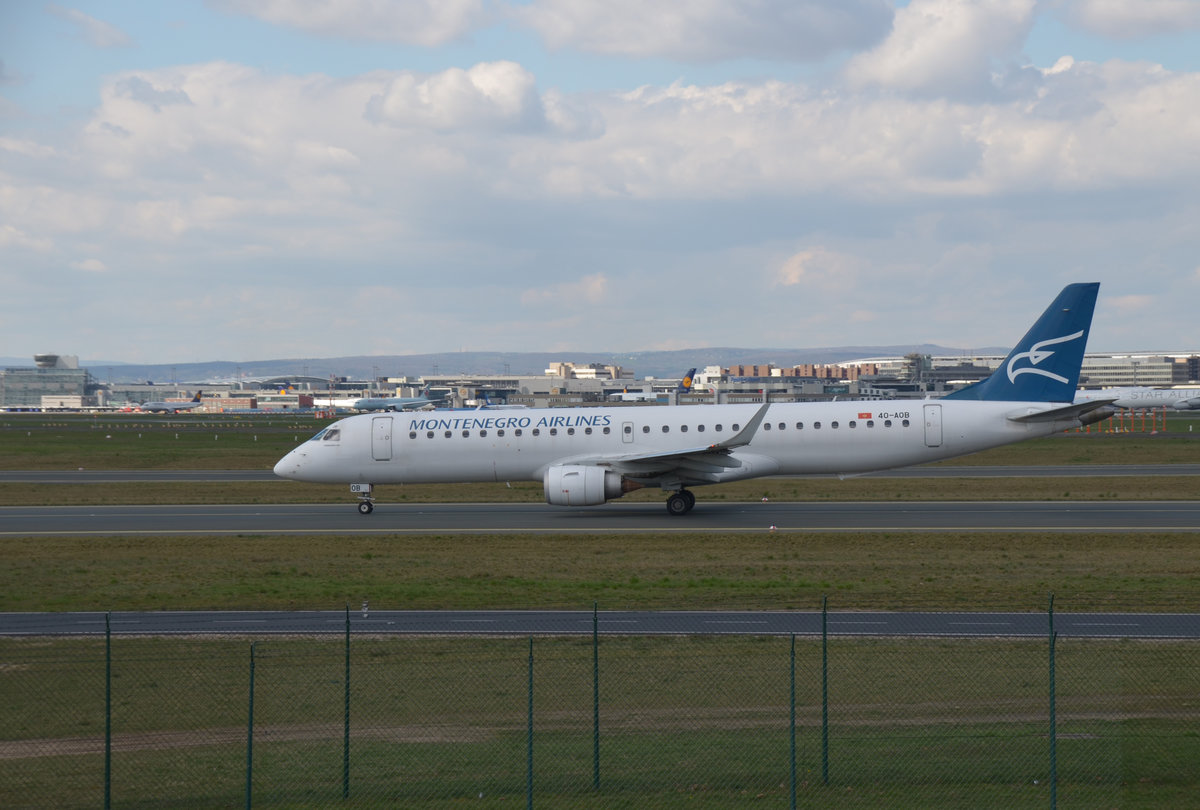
[0, 352, 1200, 413]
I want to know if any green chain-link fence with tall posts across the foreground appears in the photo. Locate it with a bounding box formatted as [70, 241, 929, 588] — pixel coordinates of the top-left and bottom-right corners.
[0, 604, 1200, 808]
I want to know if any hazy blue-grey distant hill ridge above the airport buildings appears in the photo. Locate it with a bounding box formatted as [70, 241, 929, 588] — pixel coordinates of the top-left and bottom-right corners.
[63, 343, 1008, 383]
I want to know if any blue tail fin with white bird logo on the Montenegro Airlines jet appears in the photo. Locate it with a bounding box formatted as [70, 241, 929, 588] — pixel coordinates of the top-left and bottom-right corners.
[944, 282, 1100, 402]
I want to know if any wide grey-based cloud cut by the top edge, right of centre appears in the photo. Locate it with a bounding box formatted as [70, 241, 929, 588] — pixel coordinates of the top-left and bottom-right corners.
[510, 0, 893, 62]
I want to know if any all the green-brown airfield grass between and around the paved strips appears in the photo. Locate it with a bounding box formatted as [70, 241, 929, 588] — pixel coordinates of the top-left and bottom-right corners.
[0, 415, 1200, 809]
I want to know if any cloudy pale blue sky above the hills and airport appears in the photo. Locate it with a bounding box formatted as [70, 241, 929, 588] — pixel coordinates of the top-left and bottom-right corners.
[0, 0, 1200, 364]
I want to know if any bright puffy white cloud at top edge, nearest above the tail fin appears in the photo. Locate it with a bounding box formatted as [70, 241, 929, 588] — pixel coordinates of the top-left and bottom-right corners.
[846, 0, 1036, 98]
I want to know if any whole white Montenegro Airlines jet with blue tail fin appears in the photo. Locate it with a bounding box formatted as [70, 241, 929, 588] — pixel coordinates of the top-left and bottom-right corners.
[275, 283, 1111, 515]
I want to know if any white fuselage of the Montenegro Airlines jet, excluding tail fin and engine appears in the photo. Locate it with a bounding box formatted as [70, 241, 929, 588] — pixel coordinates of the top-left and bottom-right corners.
[275, 401, 1078, 486]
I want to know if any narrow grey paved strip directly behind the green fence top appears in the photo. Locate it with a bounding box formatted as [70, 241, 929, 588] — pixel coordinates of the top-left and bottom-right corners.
[0, 610, 1200, 638]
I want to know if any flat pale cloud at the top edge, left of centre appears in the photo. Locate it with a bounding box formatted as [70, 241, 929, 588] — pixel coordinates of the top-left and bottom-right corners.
[211, 0, 491, 47]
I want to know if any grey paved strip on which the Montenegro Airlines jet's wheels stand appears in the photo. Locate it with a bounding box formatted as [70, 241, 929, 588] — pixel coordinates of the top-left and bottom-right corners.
[0, 498, 1200, 536]
